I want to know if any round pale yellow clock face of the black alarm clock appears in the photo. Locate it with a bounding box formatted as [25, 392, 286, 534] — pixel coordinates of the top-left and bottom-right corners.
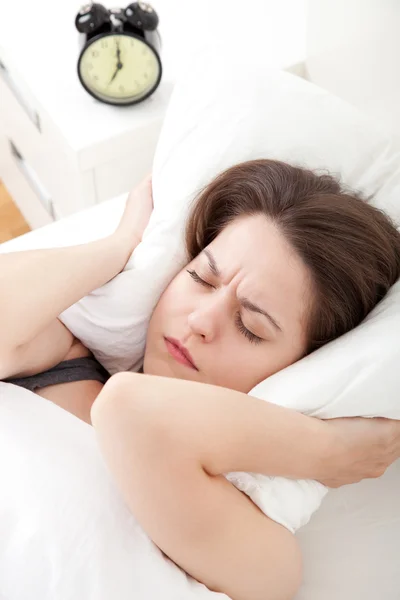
[78, 33, 161, 104]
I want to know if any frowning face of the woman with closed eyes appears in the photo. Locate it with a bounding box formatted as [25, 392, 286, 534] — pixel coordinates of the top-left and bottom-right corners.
[144, 215, 311, 393]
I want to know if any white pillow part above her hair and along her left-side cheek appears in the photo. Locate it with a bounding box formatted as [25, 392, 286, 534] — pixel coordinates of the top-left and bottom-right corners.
[62, 55, 400, 380]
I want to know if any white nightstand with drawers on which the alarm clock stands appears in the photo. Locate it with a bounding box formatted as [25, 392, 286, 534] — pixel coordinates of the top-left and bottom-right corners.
[0, 0, 305, 228]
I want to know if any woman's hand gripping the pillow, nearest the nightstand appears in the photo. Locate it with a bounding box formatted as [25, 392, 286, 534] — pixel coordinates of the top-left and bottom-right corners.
[114, 175, 153, 255]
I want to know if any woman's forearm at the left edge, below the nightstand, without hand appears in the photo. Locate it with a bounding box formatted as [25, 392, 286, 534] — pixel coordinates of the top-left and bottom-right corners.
[0, 235, 133, 352]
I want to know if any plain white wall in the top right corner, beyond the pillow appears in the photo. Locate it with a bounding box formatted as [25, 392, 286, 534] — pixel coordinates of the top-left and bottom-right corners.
[307, 0, 400, 141]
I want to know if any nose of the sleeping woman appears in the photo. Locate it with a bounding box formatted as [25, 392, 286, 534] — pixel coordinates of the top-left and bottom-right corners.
[187, 294, 228, 342]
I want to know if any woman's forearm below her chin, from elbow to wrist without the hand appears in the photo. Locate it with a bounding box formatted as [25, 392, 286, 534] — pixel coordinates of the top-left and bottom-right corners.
[100, 373, 336, 479]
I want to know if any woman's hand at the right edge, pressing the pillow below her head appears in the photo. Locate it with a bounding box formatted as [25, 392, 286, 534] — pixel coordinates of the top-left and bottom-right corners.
[320, 417, 400, 488]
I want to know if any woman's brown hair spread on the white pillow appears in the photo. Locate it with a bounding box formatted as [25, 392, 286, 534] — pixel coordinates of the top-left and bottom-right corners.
[186, 160, 400, 354]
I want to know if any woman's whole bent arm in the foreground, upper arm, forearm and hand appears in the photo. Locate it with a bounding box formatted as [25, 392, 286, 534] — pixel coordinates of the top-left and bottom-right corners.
[91, 373, 400, 600]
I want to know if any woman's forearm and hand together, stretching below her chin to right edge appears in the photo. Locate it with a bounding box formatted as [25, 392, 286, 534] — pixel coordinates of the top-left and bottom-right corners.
[93, 373, 400, 487]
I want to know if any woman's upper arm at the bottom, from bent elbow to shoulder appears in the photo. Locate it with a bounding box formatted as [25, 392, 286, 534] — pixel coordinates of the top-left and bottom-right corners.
[91, 374, 301, 600]
